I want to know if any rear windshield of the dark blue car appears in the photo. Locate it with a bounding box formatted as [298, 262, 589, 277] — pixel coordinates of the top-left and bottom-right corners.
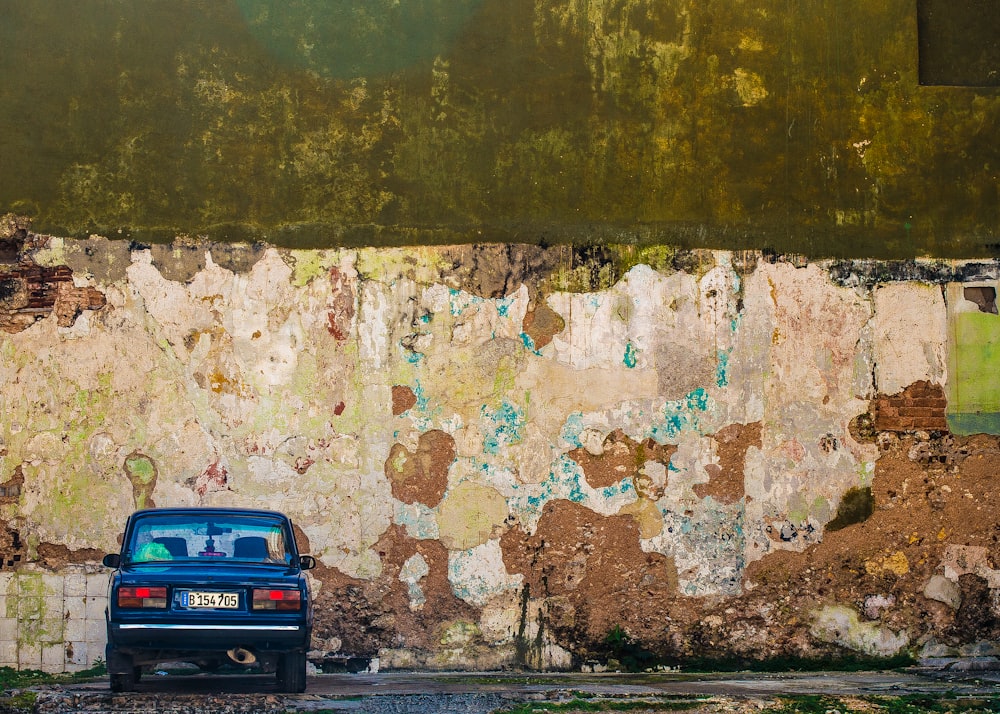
[125, 514, 292, 564]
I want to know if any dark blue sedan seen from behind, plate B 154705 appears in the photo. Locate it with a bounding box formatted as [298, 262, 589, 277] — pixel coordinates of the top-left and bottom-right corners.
[104, 508, 316, 692]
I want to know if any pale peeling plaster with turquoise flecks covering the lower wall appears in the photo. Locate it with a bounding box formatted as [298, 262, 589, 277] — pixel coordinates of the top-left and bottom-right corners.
[0, 239, 1000, 666]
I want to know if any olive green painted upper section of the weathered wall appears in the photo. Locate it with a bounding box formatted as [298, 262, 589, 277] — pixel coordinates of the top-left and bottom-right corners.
[0, 0, 1000, 257]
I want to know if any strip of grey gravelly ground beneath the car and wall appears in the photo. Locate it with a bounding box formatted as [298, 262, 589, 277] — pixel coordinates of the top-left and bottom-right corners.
[0, 671, 1000, 714]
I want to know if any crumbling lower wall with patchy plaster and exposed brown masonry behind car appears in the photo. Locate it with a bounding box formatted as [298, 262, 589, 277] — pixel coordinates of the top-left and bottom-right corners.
[0, 225, 1000, 669]
